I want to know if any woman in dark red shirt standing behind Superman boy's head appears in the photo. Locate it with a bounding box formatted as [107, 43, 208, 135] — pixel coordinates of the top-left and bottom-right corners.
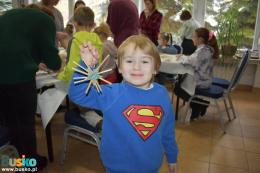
[140, 0, 163, 46]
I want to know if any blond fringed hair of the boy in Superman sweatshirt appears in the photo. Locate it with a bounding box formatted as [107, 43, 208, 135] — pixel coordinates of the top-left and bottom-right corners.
[117, 35, 161, 72]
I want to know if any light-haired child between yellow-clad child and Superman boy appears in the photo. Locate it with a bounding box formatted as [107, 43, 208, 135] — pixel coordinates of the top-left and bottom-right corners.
[94, 23, 119, 83]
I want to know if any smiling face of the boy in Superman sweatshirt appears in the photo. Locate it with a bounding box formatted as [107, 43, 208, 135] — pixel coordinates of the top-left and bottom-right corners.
[119, 44, 156, 88]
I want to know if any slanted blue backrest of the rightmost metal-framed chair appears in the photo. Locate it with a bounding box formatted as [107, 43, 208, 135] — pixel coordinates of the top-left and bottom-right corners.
[228, 50, 250, 92]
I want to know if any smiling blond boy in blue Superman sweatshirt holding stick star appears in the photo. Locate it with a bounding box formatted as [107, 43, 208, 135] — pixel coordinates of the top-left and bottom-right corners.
[69, 35, 178, 173]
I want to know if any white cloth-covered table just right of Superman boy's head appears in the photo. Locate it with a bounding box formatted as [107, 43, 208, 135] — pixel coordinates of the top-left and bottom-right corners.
[160, 54, 196, 95]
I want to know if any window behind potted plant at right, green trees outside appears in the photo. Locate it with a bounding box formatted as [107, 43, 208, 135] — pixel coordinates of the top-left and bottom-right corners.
[205, 0, 257, 49]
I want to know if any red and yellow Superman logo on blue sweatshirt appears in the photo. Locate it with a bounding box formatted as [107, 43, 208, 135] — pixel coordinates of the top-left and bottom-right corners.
[123, 105, 163, 140]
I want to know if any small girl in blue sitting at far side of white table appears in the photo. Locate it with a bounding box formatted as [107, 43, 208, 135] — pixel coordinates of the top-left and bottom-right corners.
[157, 32, 178, 54]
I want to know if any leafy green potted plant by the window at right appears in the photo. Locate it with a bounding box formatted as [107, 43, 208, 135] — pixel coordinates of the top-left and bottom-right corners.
[217, 9, 243, 56]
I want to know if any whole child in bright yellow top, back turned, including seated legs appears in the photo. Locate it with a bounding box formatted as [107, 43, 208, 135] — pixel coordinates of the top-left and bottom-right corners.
[58, 7, 103, 131]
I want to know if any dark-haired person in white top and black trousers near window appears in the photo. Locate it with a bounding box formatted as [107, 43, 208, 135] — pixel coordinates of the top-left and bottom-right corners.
[180, 10, 200, 55]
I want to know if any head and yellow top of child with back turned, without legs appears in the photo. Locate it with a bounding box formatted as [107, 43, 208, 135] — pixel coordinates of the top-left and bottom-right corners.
[58, 7, 103, 83]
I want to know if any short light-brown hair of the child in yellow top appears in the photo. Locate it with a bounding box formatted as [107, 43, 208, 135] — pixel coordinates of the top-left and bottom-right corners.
[73, 6, 95, 27]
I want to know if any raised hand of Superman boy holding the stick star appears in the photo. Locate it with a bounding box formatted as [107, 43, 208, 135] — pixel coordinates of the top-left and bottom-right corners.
[80, 42, 98, 66]
